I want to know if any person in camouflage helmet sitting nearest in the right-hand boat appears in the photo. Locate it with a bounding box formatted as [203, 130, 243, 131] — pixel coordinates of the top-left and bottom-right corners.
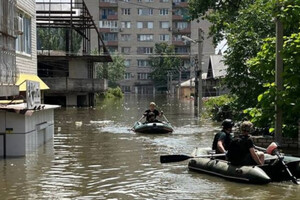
[226, 121, 265, 165]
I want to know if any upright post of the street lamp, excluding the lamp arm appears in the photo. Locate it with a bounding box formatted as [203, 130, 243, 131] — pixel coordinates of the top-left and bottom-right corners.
[196, 28, 203, 117]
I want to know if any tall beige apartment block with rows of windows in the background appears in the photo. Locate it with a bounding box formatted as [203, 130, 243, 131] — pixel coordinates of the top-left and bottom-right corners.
[88, 0, 214, 94]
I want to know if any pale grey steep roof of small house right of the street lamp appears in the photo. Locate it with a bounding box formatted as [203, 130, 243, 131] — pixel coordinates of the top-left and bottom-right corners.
[207, 55, 228, 79]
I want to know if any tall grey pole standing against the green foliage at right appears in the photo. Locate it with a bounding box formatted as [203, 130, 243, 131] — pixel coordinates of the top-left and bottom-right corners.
[275, 14, 283, 144]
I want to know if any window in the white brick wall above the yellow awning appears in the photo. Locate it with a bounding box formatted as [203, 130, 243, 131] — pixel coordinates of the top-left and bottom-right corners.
[16, 14, 31, 54]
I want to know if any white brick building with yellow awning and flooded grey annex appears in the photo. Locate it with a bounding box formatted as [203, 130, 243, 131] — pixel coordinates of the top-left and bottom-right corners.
[0, 0, 58, 157]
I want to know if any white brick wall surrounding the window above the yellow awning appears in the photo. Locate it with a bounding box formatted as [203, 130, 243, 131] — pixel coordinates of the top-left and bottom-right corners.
[16, 0, 37, 74]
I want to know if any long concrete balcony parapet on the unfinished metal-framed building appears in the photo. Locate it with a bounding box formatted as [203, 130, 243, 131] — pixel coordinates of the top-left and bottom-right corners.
[41, 77, 107, 93]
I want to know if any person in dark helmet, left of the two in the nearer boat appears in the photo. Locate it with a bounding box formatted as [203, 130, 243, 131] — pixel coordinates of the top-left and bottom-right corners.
[212, 119, 234, 153]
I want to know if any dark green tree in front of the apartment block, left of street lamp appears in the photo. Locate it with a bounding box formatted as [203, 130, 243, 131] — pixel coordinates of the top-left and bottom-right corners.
[150, 43, 182, 91]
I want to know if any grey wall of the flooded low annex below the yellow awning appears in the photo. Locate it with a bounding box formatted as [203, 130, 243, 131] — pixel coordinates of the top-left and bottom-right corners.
[0, 109, 54, 156]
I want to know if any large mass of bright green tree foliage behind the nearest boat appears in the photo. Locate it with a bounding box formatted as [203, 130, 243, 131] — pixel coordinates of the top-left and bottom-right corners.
[189, 0, 300, 136]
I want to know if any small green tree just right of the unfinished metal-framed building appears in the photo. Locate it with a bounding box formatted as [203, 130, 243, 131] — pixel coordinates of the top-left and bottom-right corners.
[96, 55, 126, 87]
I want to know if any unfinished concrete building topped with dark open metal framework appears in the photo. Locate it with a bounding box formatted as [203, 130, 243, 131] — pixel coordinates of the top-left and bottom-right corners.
[36, 0, 112, 106]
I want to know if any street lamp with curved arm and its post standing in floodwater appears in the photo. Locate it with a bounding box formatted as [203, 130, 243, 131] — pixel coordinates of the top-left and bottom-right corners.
[181, 28, 203, 116]
